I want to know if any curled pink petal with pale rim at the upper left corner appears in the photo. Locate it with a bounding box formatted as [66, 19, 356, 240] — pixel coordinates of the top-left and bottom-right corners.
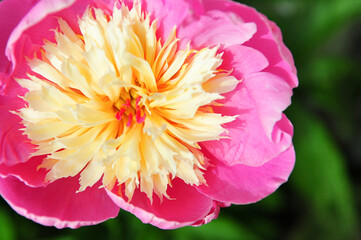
[5, 0, 91, 81]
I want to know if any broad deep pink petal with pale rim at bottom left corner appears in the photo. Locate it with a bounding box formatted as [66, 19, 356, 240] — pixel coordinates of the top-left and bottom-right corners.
[0, 176, 119, 228]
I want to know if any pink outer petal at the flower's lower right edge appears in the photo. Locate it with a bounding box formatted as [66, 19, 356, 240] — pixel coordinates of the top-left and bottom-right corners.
[197, 147, 295, 204]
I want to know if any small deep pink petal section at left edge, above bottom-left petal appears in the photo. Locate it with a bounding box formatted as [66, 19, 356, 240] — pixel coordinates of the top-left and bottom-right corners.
[0, 156, 47, 187]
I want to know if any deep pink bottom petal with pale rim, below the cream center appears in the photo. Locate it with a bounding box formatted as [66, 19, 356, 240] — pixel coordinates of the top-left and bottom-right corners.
[108, 179, 215, 229]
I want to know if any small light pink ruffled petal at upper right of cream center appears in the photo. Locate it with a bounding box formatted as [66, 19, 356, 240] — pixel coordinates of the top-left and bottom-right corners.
[178, 10, 257, 49]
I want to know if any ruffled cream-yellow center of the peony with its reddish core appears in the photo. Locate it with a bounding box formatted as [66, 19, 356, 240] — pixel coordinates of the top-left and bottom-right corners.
[17, 3, 239, 200]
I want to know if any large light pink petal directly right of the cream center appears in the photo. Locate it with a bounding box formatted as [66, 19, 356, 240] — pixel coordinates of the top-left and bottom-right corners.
[201, 75, 293, 166]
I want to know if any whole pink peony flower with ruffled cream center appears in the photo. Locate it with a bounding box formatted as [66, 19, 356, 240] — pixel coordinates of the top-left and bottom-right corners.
[0, 0, 298, 229]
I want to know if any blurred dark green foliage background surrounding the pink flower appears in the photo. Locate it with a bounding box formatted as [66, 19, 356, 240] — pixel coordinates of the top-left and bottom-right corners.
[0, 0, 361, 240]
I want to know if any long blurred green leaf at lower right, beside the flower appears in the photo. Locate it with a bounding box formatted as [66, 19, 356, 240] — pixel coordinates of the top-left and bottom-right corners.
[291, 105, 357, 239]
